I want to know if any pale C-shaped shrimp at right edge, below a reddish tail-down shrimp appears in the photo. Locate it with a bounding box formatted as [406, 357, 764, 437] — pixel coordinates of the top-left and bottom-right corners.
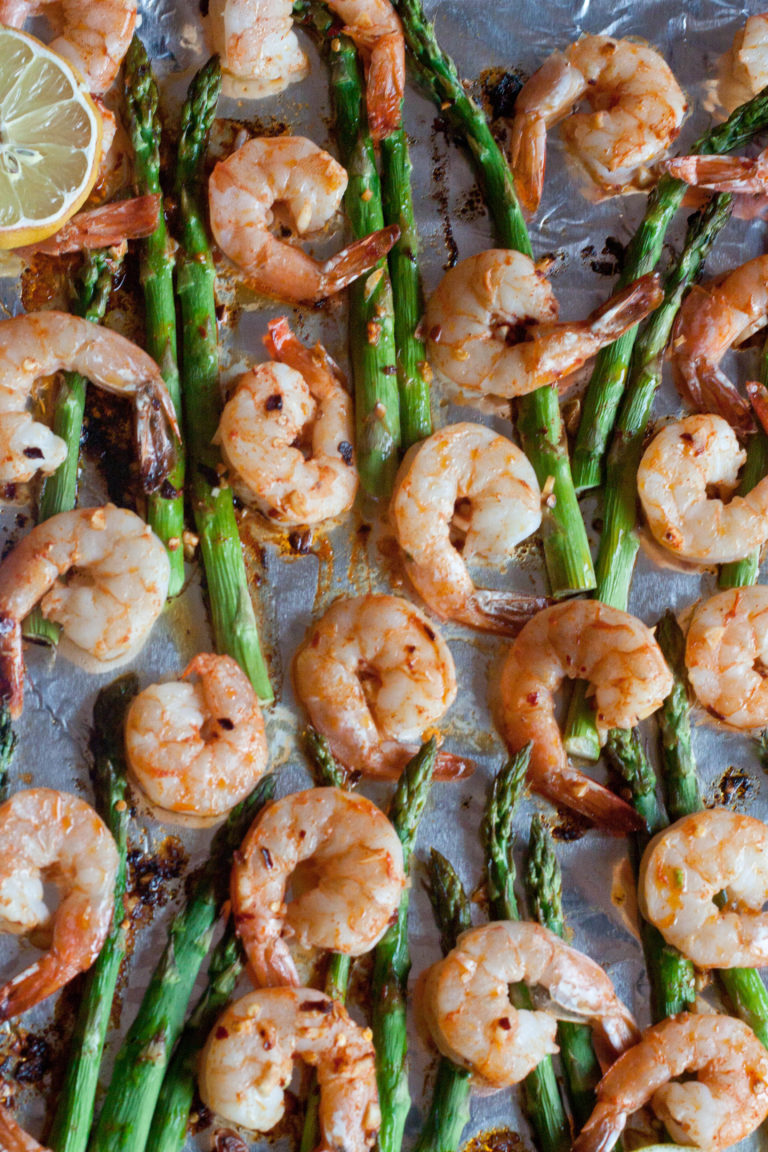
[638, 415, 768, 564]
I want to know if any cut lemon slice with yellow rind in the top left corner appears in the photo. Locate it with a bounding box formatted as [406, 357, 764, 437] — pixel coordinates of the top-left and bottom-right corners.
[0, 24, 101, 249]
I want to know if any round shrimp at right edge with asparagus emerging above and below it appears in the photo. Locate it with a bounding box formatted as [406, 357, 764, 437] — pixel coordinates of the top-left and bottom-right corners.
[638, 808, 768, 968]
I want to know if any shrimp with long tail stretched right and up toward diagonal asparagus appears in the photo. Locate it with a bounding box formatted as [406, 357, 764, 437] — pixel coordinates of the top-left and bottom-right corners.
[425, 249, 661, 407]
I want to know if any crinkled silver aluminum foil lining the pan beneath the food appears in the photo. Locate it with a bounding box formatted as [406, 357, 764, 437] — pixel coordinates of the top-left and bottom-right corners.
[0, 0, 768, 1149]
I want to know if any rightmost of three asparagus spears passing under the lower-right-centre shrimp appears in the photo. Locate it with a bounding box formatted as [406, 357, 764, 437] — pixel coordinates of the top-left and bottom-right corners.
[525, 814, 601, 1128]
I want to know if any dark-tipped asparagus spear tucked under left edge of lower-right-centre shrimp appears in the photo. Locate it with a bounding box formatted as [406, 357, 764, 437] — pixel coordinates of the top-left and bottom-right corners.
[413, 848, 472, 1152]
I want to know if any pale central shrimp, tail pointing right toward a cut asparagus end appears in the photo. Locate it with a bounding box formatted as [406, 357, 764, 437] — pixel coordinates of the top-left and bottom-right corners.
[391, 424, 550, 635]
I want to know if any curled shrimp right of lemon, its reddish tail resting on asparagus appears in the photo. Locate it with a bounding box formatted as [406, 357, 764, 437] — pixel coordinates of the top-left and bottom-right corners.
[208, 136, 400, 302]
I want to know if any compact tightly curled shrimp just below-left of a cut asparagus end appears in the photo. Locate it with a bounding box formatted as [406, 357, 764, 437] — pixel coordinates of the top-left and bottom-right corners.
[126, 653, 268, 816]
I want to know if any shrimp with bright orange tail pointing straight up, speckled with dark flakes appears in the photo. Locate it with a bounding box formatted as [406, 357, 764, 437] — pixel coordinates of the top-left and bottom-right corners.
[216, 317, 358, 524]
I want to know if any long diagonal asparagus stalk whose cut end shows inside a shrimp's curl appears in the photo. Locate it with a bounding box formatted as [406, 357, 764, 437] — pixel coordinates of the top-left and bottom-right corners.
[565, 195, 731, 748]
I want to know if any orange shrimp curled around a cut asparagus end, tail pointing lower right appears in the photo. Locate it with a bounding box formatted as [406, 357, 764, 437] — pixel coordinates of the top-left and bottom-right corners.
[501, 600, 672, 833]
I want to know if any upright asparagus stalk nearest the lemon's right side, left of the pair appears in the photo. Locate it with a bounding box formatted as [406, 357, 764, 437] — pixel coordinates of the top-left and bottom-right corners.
[124, 36, 184, 597]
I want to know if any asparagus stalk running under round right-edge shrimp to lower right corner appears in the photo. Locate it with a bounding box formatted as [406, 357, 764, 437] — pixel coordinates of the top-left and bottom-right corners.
[656, 612, 768, 1047]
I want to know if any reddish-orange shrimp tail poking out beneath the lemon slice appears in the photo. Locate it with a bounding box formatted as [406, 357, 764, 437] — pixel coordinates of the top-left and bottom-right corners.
[16, 192, 160, 257]
